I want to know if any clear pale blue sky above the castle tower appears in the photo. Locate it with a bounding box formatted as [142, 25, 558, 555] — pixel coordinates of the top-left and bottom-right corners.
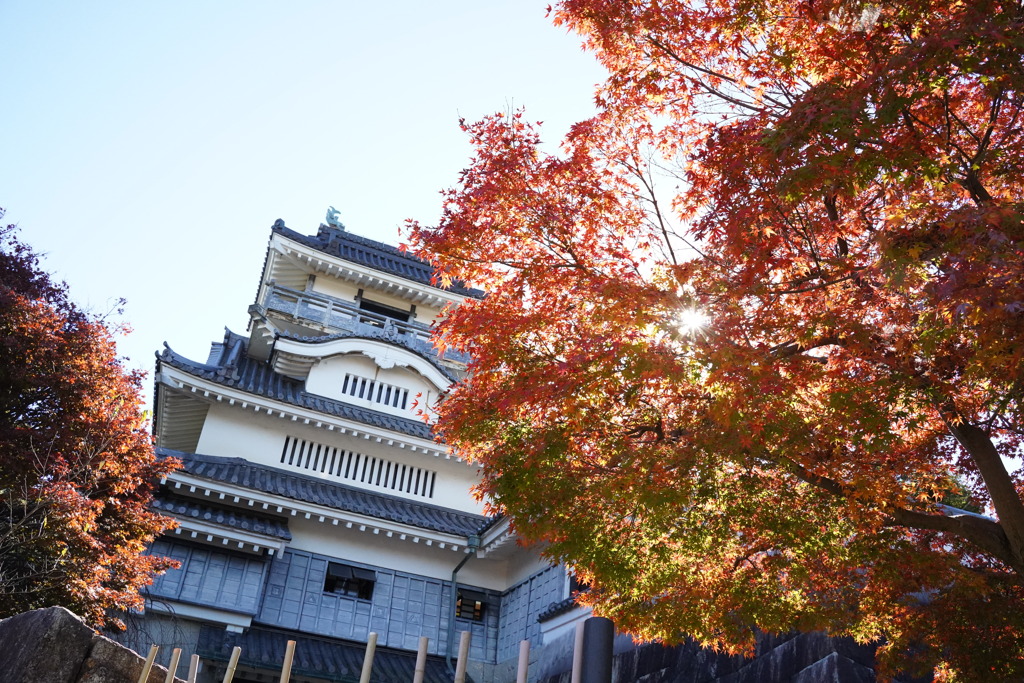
[0, 0, 602, 401]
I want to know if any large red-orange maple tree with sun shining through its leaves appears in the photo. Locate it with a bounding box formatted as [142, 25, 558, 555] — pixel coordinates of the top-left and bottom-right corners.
[412, 0, 1024, 680]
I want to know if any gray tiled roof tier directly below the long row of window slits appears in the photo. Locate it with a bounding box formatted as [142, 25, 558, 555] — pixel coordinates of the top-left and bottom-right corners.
[157, 449, 487, 537]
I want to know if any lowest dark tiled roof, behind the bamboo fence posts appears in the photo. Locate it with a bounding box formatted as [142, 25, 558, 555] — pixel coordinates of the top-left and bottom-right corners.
[197, 626, 452, 683]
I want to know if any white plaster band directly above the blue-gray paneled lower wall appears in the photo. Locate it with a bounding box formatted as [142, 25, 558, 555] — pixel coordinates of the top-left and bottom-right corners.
[288, 517, 512, 591]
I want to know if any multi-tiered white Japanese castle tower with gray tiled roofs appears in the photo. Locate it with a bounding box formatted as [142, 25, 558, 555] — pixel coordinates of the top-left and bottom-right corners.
[136, 218, 571, 683]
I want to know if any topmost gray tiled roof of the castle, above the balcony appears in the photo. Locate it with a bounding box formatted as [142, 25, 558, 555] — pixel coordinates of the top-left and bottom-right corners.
[272, 222, 483, 299]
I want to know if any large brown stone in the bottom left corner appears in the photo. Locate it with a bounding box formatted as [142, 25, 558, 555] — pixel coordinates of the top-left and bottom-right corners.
[0, 607, 180, 683]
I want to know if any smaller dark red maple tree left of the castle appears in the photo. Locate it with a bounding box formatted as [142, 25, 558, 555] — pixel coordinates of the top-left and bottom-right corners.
[0, 219, 176, 627]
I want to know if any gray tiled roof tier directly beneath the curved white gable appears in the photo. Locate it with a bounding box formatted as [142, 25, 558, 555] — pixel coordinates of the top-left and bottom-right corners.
[158, 342, 433, 439]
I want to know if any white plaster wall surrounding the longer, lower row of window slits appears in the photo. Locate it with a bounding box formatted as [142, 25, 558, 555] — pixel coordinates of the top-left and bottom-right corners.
[197, 403, 483, 514]
